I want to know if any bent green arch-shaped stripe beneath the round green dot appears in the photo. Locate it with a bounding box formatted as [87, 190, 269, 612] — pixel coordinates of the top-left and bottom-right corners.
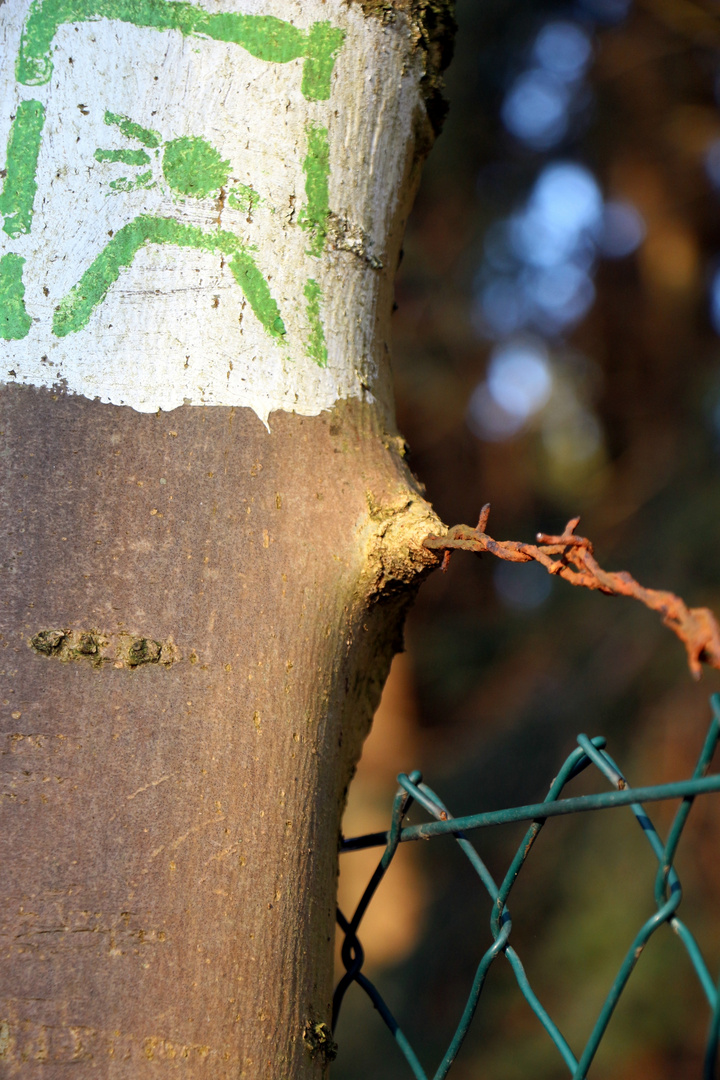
[53, 214, 285, 337]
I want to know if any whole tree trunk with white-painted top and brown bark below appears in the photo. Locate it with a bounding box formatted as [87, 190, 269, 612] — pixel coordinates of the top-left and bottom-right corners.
[0, 0, 451, 1080]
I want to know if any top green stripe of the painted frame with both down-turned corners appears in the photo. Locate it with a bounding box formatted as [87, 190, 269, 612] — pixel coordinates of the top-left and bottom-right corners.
[15, 0, 344, 100]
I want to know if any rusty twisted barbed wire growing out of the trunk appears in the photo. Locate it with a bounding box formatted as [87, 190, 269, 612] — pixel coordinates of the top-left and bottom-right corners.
[423, 502, 720, 679]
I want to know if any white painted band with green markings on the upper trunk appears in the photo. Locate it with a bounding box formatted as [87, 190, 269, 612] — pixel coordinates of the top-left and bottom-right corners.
[0, 0, 421, 423]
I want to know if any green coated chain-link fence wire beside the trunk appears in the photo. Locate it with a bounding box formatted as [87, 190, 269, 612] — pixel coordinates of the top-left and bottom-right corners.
[332, 694, 720, 1080]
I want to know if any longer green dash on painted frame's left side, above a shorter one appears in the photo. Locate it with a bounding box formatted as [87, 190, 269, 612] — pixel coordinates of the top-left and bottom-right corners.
[0, 102, 45, 237]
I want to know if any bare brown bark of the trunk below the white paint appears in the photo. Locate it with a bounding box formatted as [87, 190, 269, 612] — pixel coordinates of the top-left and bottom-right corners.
[0, 4, 451, 1080]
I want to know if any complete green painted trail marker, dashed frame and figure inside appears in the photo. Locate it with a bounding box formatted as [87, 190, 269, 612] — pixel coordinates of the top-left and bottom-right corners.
[0, 0, 345, 367]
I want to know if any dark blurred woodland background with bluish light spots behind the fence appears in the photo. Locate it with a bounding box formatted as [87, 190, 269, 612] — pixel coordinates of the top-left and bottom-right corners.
[332, 0, 720, 1080]
